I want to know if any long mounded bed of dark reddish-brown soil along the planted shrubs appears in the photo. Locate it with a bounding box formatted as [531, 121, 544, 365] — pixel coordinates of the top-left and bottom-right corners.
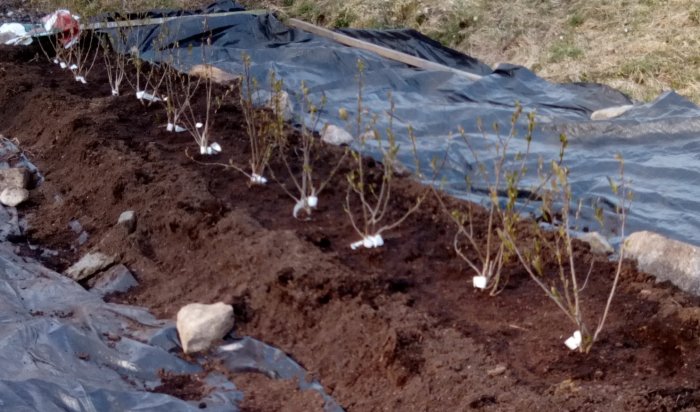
[0, 43, 700, 411]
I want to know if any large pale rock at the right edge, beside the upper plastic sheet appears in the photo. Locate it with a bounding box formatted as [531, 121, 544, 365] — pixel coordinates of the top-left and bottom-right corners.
[625, 231, 700, 295]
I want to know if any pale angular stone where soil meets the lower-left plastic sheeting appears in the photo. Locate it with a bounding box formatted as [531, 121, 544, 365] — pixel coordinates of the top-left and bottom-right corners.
[177, 302, 233, 353]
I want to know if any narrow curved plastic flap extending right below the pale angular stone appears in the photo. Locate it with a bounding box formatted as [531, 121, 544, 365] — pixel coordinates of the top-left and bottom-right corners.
[216, 337, 343, 412]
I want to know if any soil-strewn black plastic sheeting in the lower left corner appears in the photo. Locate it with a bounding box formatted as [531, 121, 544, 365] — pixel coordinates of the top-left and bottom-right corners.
[0, 147, 342, 412]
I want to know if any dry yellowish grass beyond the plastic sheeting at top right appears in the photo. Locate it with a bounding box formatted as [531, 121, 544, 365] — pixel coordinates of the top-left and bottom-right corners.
[243, 0, 700, 103]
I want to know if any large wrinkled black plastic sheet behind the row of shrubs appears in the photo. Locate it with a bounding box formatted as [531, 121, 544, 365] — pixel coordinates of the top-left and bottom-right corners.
[102, 2, 700, 244]
